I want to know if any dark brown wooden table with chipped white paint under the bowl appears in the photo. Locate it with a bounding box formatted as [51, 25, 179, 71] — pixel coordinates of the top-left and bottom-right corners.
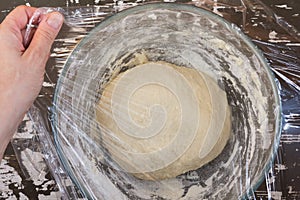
[0, 0, 300, 200]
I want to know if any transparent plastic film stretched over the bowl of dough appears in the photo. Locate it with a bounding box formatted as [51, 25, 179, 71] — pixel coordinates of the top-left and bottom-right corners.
[16, 1, 300, 199]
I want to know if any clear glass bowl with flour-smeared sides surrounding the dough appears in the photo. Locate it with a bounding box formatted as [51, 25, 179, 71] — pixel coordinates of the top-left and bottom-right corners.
[52, 3, 281, 199]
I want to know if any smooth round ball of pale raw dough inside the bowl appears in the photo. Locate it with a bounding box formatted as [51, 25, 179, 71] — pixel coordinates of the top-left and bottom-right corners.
[96, 62, 231, 180]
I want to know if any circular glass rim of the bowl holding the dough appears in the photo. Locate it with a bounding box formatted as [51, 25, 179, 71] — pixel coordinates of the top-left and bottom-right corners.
[51, 2, 283, 199]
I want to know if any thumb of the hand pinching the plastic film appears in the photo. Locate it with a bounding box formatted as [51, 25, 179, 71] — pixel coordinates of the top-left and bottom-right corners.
[23, 12, 64, 67]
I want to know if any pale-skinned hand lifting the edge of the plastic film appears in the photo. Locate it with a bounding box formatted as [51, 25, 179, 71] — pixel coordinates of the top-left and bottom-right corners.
[0, 6, 63, 161]
